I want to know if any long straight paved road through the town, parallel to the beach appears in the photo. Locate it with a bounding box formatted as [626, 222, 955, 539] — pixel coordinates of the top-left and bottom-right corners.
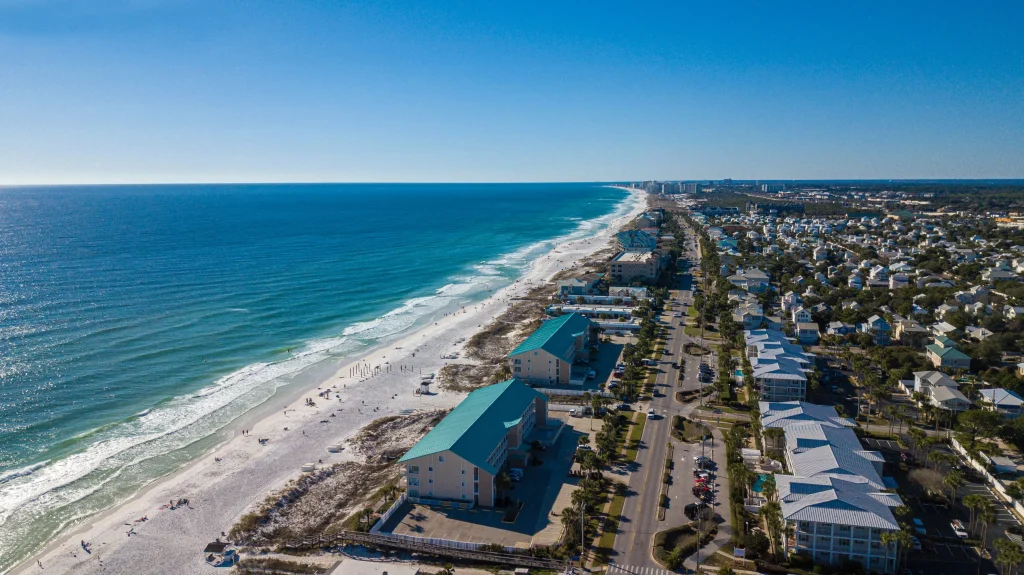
[609, 219, 728, 574]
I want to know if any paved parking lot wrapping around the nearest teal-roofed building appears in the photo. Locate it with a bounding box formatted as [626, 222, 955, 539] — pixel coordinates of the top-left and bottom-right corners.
[383, 418, 589, 546]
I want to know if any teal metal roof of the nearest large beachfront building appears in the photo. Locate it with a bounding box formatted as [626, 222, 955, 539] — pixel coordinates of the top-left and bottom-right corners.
[398, 380, 546, 474]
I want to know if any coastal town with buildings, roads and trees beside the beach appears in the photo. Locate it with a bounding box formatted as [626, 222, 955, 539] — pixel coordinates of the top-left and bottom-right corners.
[18, 181, 1024, 575]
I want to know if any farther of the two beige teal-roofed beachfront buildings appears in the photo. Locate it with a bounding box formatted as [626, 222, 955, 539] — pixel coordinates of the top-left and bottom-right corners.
[508, 313, 597, 386]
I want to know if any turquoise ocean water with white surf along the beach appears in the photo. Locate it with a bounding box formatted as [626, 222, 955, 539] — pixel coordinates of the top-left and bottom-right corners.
[0, 184, 627, 572]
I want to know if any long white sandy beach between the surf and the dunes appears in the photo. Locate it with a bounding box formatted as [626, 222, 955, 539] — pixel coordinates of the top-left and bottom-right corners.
[9, 186, 646, 573]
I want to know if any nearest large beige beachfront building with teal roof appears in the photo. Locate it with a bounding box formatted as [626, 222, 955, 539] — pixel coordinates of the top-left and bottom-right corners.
[398, 379, 561, 507]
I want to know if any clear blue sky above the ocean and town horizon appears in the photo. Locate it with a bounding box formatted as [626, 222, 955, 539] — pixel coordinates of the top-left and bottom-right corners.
[0, 0, 1024, 184]
